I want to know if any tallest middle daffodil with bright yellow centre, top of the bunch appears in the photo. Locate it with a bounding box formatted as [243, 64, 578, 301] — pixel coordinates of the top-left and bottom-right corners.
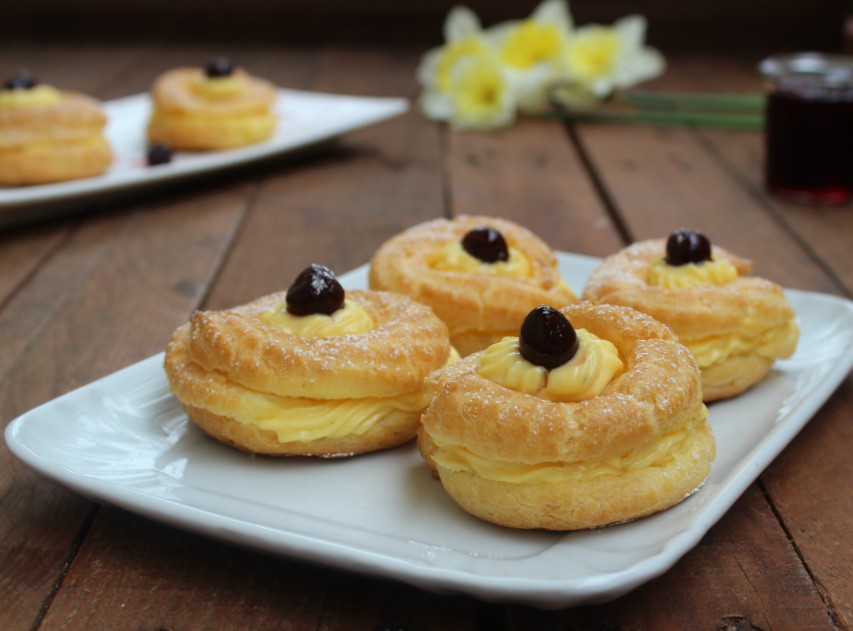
[488, 0, 573, 114]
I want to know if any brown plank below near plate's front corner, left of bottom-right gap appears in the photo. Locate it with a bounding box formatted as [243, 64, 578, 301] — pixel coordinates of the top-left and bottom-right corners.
[509, 486, 835, 631]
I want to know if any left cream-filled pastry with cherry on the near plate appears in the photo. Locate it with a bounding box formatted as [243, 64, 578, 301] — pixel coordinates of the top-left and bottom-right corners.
[165, 265, 458, 457]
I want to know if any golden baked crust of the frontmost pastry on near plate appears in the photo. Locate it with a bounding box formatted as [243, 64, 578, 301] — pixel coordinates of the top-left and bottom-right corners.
[419, 302, 715, 530]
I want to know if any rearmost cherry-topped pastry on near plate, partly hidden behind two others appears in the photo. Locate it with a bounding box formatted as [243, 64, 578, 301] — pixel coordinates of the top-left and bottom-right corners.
[370, 215, 577, 356]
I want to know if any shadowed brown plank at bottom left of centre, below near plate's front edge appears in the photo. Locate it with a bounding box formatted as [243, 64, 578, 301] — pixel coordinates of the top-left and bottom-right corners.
[40, 507, 475, 631]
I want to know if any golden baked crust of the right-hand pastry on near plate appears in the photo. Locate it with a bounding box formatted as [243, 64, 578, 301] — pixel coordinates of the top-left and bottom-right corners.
[583, 239, 798, 401]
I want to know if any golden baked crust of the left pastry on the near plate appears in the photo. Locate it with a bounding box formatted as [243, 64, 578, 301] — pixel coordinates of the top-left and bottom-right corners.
[164, 290, 450, 456]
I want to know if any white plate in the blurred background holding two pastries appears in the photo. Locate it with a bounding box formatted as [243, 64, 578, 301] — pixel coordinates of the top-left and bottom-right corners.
[0, 89, 409, 223]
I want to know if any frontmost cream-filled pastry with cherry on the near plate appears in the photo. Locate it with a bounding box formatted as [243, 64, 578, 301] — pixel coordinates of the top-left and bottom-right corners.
[418, 302, 716, 530]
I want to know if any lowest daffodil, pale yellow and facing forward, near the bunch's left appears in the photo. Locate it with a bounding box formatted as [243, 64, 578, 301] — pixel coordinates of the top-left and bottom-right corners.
[442, 53, 516, 130]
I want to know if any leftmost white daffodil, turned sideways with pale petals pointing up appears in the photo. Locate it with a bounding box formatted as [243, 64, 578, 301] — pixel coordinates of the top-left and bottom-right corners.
[417, 6, 490, 120]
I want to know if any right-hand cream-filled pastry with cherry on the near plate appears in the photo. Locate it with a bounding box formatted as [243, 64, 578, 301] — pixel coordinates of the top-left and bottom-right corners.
[584, 230, 799, 401]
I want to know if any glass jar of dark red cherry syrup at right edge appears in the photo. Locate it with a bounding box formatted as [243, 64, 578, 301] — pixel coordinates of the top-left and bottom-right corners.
[760, 53, 853, 204]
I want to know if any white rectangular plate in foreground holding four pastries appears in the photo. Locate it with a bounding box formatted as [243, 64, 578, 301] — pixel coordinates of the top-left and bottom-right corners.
[6, 254, 853, 608]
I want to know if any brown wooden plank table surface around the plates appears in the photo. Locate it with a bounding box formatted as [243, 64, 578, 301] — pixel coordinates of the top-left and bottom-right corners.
[5, 42, 853, 631]
